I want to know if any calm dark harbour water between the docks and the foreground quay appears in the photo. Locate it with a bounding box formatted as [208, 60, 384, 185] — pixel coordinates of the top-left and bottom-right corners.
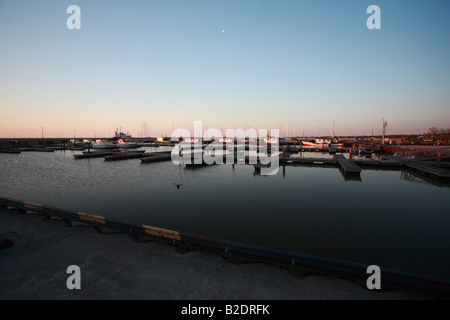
[0, 148, 450, 278]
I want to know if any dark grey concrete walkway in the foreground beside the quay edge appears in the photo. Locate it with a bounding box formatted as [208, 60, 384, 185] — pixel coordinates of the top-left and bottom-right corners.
[0, 210, 432, 300]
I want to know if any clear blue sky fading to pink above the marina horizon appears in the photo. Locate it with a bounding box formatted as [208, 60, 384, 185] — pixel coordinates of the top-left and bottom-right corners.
[0, 0, 450, 138]
